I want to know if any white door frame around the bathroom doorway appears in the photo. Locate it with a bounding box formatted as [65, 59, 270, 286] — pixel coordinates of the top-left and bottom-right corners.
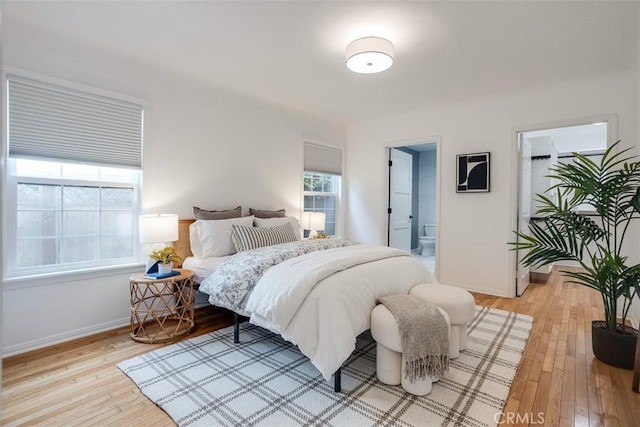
[379, 136, 442, 279]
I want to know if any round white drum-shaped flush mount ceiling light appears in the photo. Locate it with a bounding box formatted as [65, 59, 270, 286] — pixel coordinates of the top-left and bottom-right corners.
[347, 37, 393, 74]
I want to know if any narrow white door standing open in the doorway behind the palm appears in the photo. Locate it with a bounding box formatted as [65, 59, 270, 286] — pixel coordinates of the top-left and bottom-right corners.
[516, 133, 532, 296]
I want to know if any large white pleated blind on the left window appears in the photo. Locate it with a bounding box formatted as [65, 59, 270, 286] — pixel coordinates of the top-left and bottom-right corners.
[7, 75, 143, 168]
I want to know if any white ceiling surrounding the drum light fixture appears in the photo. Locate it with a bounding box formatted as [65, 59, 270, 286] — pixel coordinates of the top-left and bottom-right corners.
[2, 0, 640, 123]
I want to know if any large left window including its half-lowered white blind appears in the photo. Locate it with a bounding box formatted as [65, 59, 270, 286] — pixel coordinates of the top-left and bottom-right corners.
[4, 76, 143, 278]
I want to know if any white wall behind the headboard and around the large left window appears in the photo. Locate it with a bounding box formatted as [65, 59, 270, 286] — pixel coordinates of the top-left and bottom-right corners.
[2, 25, 346, 355]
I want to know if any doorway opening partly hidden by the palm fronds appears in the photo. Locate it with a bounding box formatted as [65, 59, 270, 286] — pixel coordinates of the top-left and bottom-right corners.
[515, 119, 614, 296]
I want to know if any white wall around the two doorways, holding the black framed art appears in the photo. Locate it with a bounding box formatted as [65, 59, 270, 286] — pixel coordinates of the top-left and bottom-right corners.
[347, 70, 640, 296]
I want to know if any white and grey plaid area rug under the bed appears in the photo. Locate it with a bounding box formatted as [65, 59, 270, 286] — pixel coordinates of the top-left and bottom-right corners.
[118, 306, 533, 427]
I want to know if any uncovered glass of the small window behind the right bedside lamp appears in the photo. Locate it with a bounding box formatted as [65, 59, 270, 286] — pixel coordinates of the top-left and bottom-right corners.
[304, 172, 340, 237]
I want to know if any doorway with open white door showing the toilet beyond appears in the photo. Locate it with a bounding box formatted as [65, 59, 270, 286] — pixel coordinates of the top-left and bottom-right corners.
[385, 142, 439, 273]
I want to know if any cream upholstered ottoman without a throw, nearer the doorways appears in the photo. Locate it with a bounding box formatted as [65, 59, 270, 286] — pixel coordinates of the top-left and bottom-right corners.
[409, 283, 476, 359]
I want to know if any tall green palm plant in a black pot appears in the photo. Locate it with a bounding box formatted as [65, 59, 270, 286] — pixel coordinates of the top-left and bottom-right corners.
[510, 141, 640, 369]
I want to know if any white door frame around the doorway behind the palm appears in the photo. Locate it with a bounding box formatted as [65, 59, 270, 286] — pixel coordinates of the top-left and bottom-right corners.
[506, 113, 618, 298]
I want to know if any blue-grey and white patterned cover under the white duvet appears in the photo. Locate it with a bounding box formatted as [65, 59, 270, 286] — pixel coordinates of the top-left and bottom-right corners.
[199, 239, 357, 314]
